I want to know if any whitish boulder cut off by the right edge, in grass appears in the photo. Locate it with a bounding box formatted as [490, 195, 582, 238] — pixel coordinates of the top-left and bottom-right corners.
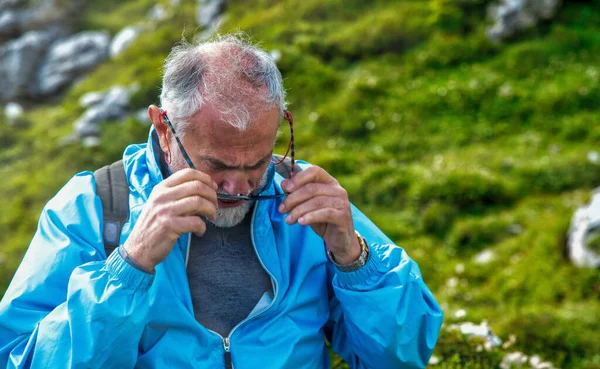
[567, 188, 600, 268]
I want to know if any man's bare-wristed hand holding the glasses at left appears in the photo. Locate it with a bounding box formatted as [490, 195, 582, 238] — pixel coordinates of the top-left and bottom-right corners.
[122, 168, 218, 272]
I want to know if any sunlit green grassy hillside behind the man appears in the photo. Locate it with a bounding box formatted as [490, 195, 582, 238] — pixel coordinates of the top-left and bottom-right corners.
[0, 0, 600, 369]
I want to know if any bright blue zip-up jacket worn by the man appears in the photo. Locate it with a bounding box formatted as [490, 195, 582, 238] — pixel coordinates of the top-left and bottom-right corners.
[0, 130, 443, 369]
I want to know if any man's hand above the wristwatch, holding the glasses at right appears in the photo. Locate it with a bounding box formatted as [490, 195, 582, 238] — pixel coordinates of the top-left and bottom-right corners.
[279, 166, 361, 264]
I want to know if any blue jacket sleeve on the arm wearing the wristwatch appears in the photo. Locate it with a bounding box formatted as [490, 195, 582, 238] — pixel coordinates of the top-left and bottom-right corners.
[325, 206, 443, 369]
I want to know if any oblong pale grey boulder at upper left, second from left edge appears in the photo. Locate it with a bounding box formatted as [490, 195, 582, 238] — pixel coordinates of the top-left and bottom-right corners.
[36, 31, 110, 96]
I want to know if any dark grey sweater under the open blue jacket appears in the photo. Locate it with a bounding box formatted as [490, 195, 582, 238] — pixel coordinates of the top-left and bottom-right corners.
[187, 210, 272, 337]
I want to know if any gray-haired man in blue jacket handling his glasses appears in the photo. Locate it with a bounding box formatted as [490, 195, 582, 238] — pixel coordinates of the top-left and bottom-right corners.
[0, 36, 443, 369]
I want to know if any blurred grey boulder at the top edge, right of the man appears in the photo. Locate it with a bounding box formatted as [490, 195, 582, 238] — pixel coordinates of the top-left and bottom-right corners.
[487, 0, 561, 42]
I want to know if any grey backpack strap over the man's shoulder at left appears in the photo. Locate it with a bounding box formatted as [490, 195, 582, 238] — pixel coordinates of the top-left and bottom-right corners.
[94, 160, 129, 257]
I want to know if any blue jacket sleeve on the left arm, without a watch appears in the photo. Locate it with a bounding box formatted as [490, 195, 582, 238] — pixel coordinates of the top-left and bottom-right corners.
[0, 172, 154, 368]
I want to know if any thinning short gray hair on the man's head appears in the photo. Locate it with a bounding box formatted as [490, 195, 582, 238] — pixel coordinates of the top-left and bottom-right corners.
[160, 33, 287, 135]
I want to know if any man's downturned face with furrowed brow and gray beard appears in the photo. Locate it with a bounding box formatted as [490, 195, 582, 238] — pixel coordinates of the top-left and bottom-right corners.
[170, 103, 279, 227]
